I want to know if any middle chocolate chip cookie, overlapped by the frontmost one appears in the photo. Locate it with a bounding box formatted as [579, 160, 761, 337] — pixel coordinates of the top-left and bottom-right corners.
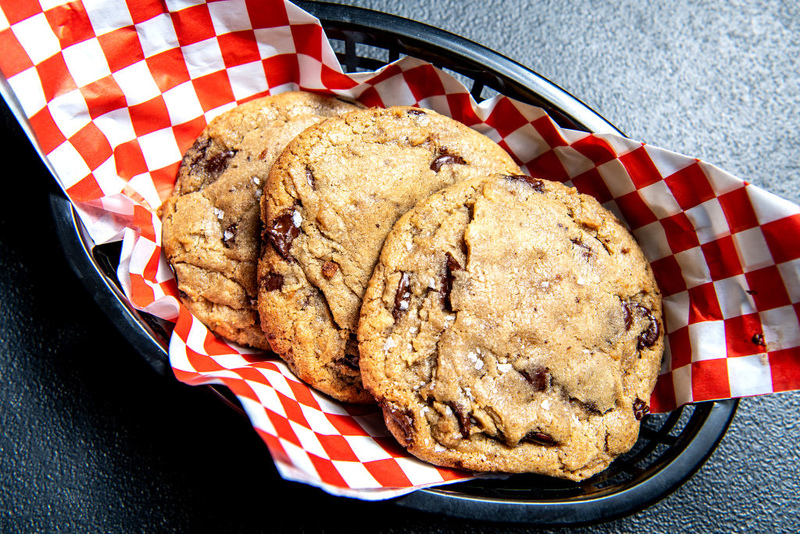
[258, 107, 519, 402]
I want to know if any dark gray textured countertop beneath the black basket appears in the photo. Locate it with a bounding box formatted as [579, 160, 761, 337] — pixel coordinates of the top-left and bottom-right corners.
[0, 0, 800, 533]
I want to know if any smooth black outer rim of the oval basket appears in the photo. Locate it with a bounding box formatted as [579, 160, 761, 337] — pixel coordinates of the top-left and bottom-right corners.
[36, 1, 739, 526]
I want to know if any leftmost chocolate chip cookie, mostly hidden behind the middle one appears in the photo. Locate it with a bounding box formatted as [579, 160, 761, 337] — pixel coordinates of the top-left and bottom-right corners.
[160, 91, 358, 349]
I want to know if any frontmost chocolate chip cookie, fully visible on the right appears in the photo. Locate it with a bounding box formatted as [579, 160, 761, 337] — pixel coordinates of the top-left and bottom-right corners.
[358, 176, 663, 481]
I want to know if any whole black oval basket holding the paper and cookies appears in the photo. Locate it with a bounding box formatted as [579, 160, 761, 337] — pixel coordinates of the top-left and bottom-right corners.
[51, 2, 738, 525]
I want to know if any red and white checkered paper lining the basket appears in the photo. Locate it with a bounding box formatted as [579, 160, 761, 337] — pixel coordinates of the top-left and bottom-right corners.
[0, 0, 800, 499]
